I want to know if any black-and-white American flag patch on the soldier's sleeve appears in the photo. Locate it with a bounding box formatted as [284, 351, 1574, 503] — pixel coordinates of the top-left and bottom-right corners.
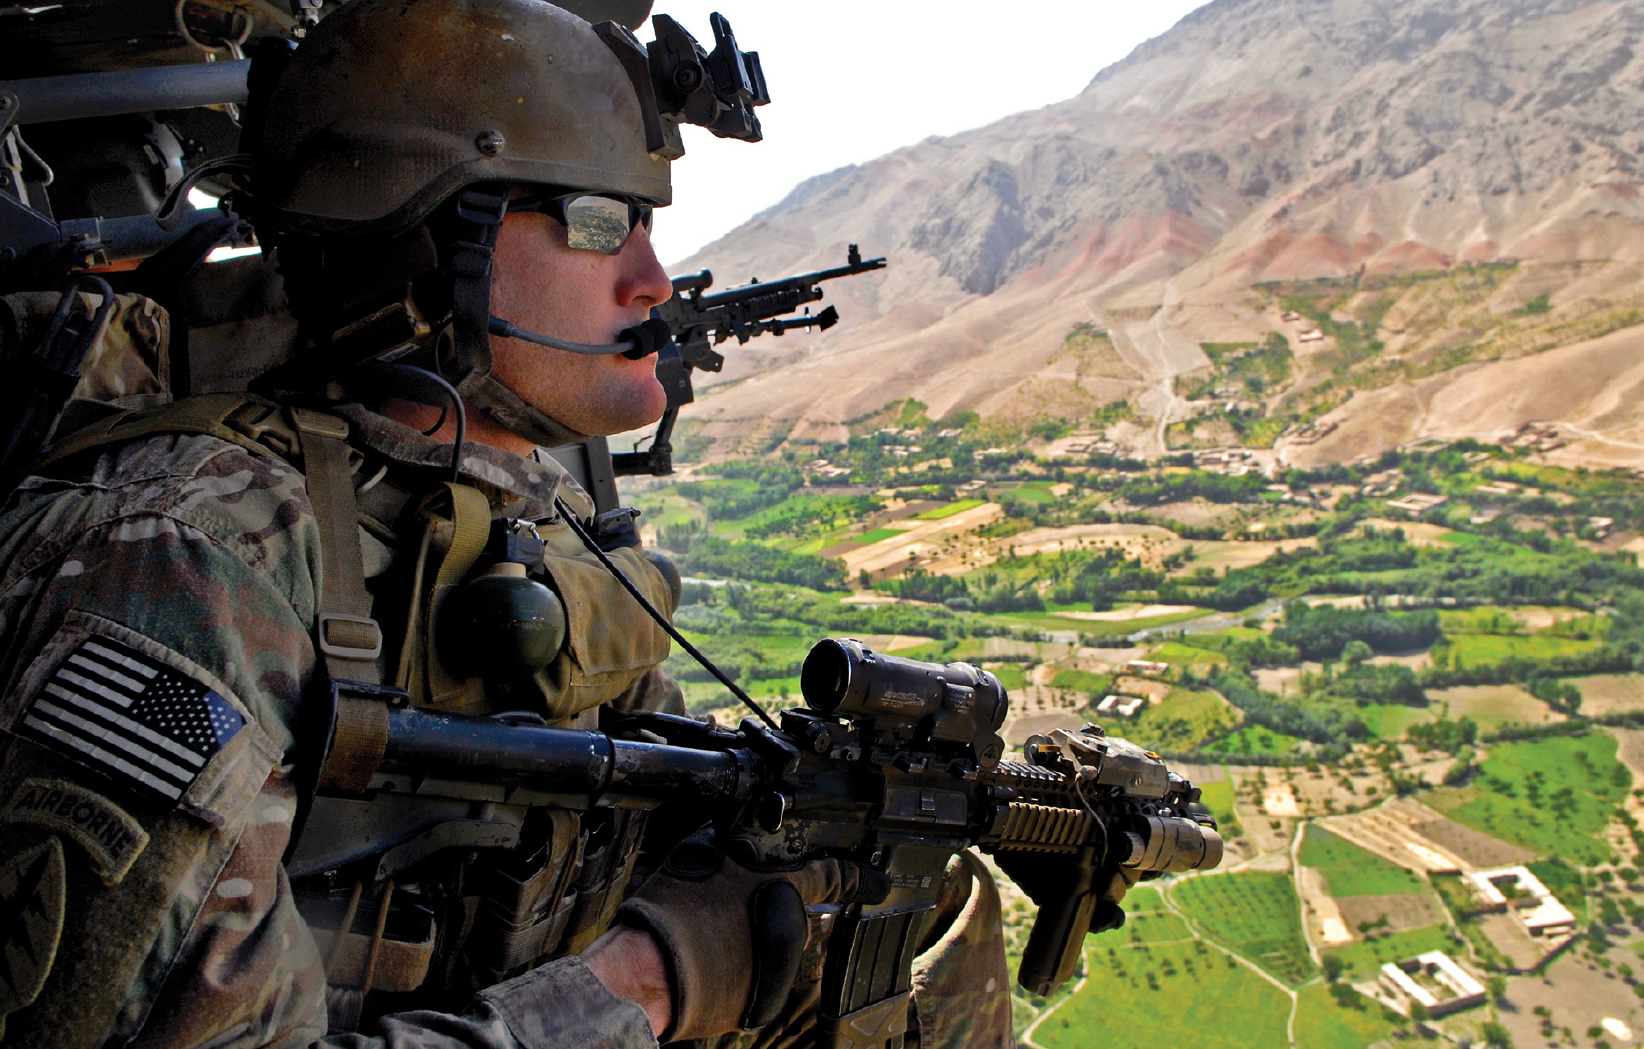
[21, 636, 245, 802]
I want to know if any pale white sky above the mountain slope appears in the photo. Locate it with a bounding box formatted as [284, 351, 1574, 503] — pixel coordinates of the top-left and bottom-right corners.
[640, 0, 1203, 268]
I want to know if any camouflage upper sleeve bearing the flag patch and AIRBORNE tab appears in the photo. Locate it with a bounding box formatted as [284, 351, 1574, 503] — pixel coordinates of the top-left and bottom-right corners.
[0, 436, 324, 1046]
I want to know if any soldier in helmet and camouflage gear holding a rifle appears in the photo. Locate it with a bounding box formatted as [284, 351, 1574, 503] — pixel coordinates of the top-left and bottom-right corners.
[0, 0, 1009, 1047]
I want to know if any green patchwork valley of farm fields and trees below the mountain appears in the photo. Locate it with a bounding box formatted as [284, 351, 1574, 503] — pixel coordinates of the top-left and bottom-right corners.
[624, 412, 1644, 1049]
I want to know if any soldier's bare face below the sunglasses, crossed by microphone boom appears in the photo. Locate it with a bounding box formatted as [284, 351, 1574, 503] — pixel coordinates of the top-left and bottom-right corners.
[492, 205, 674, 436]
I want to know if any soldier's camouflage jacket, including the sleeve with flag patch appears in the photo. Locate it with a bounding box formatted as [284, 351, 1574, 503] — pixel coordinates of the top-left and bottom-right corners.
[0, 408, 671, 1047]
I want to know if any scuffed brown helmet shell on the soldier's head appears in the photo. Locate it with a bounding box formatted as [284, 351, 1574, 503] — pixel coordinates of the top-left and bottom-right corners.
[255, 0, 671, 233]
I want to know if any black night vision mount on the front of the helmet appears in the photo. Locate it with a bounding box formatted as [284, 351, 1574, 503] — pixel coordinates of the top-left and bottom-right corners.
[593, 12, 771, 159]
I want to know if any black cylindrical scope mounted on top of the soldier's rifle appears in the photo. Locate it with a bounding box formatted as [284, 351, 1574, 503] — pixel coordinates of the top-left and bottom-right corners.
[799, 638, 1009, 755]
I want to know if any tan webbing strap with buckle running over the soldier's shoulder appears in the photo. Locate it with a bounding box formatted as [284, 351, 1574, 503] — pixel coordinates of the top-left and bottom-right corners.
[36, 393, 383, 686]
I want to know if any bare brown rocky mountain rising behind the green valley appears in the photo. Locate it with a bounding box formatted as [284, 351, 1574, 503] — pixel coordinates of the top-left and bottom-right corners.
[664, 0, 1644, 462]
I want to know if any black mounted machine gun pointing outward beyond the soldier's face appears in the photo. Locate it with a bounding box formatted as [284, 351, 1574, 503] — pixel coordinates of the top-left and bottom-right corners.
[612, 245, 884, 477]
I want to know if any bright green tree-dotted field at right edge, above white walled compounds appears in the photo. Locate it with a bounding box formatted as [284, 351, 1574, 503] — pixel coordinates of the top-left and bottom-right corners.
[1429, 732, 1632, 865]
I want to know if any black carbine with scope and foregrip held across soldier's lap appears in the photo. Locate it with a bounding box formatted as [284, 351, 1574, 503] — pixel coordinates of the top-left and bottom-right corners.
[293, 640, 1221, 1049]
